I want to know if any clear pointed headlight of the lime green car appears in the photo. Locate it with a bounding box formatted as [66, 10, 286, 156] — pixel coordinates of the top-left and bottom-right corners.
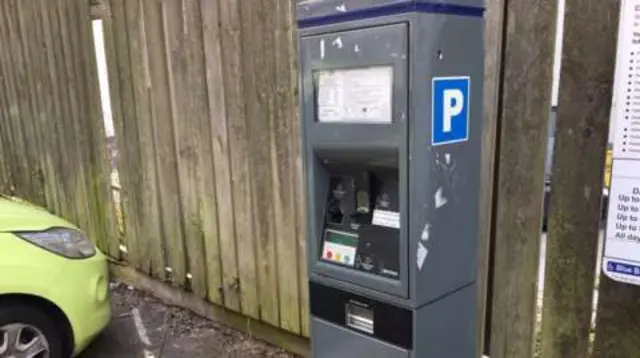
[14, 228, 96, 259]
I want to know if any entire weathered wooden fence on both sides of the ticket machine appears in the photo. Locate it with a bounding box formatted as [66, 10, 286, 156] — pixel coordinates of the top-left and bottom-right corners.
[0, 0, 640, 358]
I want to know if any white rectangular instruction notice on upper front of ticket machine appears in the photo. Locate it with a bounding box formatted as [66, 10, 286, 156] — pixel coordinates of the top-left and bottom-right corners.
[317, 66, 393, 123]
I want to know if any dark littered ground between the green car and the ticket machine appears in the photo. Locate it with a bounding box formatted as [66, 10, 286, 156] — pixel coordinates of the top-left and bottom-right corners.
[80, 284, 295, 358]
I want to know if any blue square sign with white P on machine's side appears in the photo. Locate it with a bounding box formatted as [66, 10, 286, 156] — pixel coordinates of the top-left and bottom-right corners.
[431, 77, 471, 145]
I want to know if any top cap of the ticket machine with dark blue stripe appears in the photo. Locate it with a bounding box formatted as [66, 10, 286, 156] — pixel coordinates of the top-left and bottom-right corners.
[296, 0, 484, 28]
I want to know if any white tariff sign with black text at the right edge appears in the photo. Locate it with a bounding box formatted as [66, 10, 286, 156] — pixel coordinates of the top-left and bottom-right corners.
[602, 0, 640, 285]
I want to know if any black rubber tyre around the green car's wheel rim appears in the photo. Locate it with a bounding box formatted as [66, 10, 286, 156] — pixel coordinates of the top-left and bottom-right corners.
[0, 303, 66, 358]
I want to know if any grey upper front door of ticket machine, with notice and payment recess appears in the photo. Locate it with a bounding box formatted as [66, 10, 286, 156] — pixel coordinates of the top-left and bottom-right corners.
[300, 22, 409, 298]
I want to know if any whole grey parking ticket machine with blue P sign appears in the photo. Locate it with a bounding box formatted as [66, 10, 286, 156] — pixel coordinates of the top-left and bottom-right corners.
[296, 0, 484, 358]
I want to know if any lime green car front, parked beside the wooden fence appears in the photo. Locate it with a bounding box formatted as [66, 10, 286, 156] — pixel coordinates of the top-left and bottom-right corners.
[0, 197, 111, 358]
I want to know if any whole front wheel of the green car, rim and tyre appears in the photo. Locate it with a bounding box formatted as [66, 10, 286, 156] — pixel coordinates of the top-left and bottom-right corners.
[0, 304, 63, 358]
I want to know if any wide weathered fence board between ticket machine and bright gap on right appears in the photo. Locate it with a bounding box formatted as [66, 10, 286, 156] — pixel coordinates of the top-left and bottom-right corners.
[490, 0, 556, 358]
